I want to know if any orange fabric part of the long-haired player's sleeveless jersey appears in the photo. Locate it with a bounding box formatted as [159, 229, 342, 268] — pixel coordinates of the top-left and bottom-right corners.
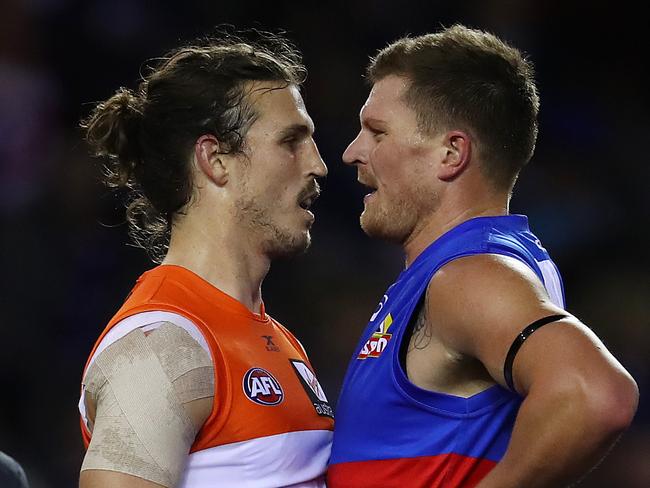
[81, 265, 333, 452]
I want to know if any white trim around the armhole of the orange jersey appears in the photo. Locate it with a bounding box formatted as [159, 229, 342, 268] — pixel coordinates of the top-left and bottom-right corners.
[79, 311, 214, 428]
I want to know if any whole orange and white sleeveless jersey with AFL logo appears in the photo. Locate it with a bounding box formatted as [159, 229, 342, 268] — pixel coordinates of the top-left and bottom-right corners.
[80, 265, 333, 488]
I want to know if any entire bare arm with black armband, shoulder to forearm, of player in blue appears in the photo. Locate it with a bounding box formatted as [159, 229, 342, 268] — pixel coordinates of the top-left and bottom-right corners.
[427, 255, 638, 488]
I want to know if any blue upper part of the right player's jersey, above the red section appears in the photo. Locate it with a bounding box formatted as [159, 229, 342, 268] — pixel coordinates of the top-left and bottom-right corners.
[330, 215, 563, 464]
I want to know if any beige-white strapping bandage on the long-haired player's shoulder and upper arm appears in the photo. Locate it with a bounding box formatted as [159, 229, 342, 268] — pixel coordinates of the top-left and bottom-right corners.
[81, 324, 214, 487]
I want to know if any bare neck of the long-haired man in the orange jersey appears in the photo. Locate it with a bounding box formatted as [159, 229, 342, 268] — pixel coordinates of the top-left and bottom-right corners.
[162, 216, 271, 313]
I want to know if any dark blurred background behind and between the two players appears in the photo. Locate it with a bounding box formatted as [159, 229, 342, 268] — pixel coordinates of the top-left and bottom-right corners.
[0, 0, 650, 488]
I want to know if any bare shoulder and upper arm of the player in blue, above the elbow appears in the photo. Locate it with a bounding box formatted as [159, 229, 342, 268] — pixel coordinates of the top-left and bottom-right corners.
[422, 255, 624, 394]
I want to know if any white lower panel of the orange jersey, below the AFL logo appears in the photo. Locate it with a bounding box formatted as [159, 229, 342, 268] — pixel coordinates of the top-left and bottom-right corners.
[179, 430, 332, 488]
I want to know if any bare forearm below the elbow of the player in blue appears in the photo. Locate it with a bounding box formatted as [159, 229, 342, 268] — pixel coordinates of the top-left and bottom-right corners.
[478, 386, 634, 488]
